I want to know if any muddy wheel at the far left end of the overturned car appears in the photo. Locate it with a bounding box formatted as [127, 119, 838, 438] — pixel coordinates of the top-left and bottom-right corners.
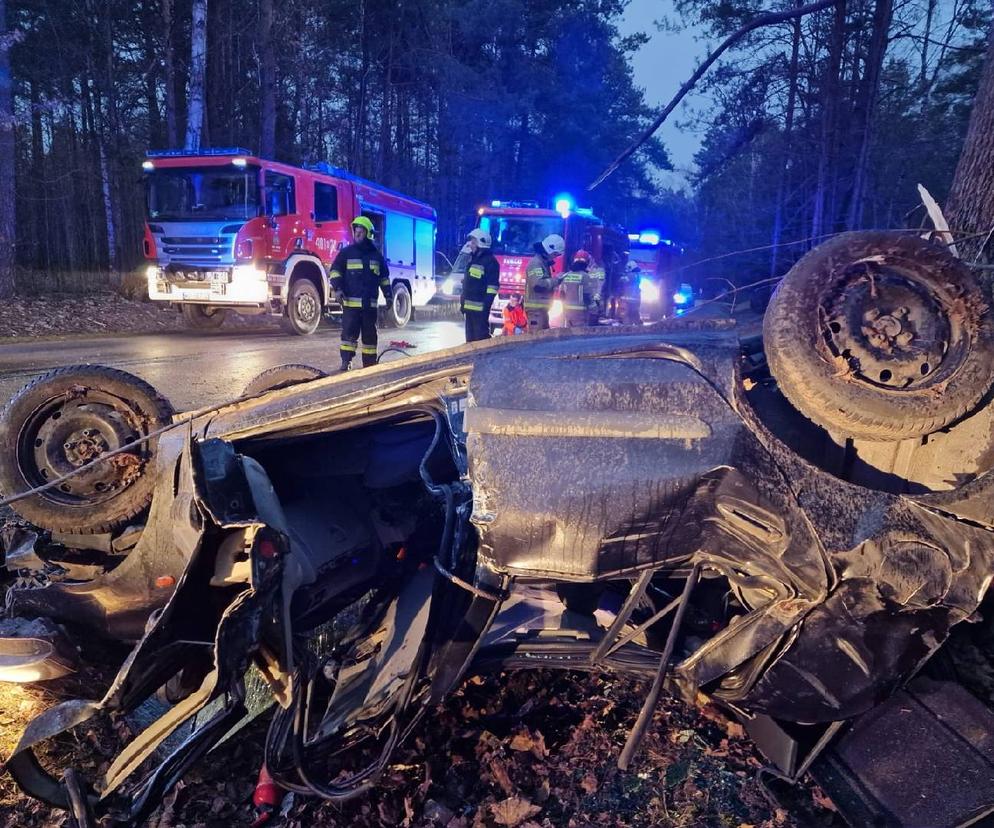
[0, 365, 173, 535]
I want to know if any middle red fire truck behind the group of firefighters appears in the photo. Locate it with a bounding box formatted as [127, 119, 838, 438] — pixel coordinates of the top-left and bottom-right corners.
[477, 199, 628, 330]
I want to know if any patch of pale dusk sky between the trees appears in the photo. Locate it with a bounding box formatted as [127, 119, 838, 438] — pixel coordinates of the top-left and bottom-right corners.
[620, 0, 707, 184]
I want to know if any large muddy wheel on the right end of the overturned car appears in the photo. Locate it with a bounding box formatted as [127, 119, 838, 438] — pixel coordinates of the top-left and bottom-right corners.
[763, 232, 994, 441]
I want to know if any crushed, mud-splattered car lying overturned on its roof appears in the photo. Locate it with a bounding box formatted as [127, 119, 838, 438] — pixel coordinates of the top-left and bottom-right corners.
[0, 234, 994, 824]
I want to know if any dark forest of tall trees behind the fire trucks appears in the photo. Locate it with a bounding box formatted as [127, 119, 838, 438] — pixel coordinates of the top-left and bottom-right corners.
[0, 0, 992, 293]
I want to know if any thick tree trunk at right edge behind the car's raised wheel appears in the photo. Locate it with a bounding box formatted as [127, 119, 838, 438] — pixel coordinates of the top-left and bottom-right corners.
[945, 26, 994, 263]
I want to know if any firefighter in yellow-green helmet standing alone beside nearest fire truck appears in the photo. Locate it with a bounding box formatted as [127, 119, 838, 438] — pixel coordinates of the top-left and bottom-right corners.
[331, 216, 393, 371]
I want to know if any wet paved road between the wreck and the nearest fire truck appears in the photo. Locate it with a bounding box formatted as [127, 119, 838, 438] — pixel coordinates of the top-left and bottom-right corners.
[0, 320, 463, 411]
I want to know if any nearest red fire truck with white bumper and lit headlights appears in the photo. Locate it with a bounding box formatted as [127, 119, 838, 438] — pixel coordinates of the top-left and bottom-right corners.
[142, 148, 436, 334]
